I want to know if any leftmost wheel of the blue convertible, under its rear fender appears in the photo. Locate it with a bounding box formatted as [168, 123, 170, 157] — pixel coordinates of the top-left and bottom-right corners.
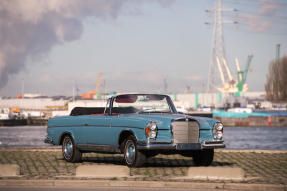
[62, 135, 82, 162]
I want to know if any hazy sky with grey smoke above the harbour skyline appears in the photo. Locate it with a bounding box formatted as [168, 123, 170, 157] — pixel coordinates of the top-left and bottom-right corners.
[0, 0, 287, 96]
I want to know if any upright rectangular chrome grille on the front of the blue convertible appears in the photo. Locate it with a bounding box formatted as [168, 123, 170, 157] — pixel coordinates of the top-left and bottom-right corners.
[172, 121, 199, 143]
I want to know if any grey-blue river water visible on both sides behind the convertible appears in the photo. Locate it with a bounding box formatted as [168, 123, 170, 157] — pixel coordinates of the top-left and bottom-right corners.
[0, 126, 287, 150]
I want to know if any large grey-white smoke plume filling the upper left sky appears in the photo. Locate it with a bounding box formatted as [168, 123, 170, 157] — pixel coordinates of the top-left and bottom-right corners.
[0, 0, 172, 88]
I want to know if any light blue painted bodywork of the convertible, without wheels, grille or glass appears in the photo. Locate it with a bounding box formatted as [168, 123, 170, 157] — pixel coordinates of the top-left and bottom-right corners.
[47, 114, 218, 146]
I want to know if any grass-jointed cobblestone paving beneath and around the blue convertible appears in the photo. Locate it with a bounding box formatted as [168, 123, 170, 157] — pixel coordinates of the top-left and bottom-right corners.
[0, 149, 287, 185]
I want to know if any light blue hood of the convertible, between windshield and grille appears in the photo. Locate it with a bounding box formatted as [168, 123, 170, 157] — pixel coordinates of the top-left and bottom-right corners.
[122, 113, 218, 130]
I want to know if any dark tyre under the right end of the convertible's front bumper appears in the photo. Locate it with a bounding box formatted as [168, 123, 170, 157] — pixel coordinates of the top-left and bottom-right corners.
[192, 149, 214, 166]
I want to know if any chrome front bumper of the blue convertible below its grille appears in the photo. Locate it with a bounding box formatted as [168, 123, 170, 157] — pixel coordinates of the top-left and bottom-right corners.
[137, 141, 225, 150]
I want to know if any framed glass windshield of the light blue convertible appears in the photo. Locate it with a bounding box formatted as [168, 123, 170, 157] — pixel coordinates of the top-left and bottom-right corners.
[113, 94, 176, 113]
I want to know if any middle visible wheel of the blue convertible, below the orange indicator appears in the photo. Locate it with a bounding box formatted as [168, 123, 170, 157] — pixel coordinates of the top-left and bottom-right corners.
[124, 135, 146, 167]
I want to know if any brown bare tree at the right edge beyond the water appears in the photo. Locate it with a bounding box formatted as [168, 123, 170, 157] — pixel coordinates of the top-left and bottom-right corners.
[265, 56, 287, 101]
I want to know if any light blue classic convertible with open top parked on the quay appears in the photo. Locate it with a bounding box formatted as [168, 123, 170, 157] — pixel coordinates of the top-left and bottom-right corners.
[45, 94, 225, 167]
